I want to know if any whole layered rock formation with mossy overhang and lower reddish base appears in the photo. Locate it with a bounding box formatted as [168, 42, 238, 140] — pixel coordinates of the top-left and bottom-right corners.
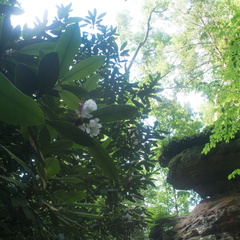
[150, 132, 240, 240]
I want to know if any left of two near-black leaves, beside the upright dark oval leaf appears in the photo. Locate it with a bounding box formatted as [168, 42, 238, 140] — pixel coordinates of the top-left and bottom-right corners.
[15, 63, 39, 96]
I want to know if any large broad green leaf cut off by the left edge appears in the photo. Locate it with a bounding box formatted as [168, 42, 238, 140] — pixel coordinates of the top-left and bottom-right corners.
[0, 73, 44, 126]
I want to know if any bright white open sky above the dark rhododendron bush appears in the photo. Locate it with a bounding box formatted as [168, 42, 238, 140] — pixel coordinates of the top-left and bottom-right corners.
[12, 0, 143, 27]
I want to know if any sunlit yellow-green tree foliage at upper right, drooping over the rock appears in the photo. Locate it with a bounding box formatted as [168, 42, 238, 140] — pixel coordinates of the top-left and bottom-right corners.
[145, 0, 239, 153]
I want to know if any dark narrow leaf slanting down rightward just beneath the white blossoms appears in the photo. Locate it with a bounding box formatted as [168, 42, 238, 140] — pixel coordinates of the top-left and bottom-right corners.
[49, 121, 94, 147]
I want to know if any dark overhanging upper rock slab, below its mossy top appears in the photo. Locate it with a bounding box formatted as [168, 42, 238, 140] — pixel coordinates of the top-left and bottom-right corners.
[167, 139, 240, 197]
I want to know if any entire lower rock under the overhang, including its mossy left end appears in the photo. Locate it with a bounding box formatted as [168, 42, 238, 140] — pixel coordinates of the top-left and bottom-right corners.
[150, 193, 240, 240]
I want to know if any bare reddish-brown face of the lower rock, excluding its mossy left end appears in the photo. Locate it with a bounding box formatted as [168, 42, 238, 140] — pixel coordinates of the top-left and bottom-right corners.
[176, 194, 240, 239]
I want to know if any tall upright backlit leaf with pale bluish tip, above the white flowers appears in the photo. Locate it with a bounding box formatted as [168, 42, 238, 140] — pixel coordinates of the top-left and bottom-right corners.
[56, 23, 80, 77]
